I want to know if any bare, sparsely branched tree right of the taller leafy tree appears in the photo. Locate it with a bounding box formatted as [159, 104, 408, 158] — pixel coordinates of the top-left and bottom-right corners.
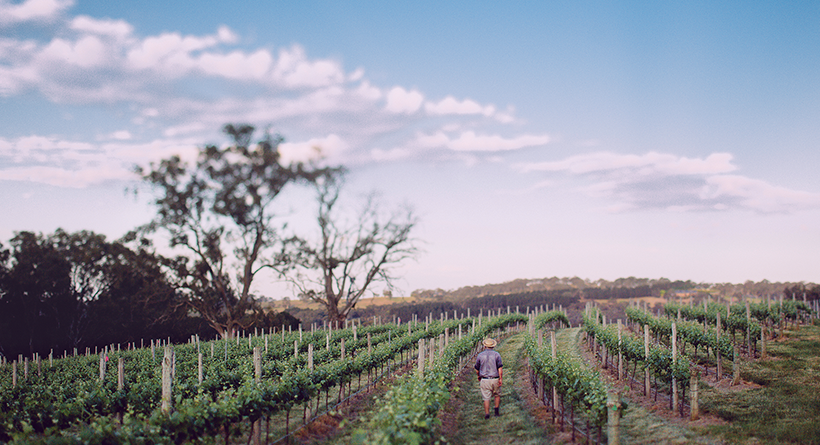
[273, 173, 418, 322]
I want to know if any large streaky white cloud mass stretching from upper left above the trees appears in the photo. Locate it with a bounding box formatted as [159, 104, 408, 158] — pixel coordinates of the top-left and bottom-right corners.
[0, 8, 572, 177]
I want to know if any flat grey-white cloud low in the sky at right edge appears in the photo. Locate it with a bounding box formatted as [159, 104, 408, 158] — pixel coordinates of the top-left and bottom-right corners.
[519, 152, 820, 213]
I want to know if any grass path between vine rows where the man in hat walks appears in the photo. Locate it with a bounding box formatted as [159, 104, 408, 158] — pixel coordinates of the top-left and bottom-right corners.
[438, 334, 549, 445]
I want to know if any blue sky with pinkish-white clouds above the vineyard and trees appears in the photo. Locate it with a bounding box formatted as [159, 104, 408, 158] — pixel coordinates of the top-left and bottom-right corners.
[0, 0, 820, 292]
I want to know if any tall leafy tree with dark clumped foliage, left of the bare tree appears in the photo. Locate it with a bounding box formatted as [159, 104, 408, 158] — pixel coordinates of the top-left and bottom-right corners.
[137, 125, 337, 337]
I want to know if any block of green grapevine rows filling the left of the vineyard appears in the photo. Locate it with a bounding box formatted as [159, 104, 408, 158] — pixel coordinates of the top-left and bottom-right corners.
[0, 319, 472, 443]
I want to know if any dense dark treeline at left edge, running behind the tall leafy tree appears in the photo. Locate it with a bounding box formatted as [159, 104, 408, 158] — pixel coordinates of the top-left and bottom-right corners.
[0, 230, 299, 359]
